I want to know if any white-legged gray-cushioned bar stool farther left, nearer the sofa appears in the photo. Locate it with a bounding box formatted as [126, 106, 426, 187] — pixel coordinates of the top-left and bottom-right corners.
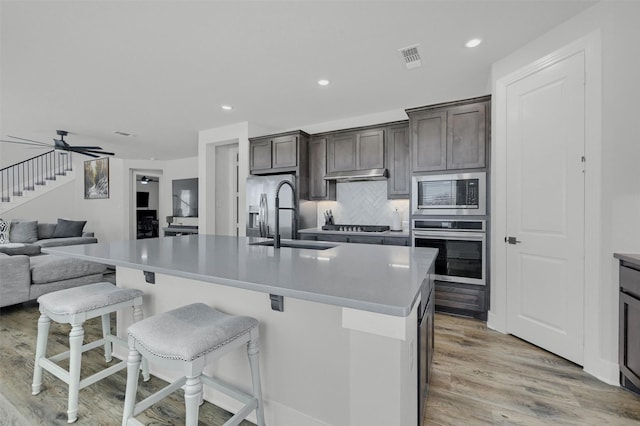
[31, 282, 149, 423]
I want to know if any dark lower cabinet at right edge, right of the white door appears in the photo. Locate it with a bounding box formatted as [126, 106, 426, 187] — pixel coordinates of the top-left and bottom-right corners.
[619, 262, 640, 394]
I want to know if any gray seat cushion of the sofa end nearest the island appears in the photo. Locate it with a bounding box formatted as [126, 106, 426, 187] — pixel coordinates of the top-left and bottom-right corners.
[31, 254, 107, 284]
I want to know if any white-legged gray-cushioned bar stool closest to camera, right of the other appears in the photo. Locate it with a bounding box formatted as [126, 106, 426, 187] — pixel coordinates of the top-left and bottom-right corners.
[122, 303, 265, 426]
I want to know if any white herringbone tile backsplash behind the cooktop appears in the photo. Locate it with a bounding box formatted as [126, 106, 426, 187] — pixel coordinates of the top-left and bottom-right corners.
[318, 180, 409, 229]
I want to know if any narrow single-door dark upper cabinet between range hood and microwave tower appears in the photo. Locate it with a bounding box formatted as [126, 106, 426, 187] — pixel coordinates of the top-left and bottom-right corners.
[387, 123, 411, 199]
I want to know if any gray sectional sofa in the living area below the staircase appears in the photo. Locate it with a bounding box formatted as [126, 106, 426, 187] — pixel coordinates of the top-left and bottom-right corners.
[0, 219, 107, 307]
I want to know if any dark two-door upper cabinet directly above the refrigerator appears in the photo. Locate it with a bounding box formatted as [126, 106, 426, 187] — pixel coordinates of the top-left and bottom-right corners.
[249, 131, 309, 175]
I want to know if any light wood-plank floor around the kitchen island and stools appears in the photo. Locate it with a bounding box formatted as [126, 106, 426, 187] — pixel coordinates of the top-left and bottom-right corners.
[0, 303, 640, 426]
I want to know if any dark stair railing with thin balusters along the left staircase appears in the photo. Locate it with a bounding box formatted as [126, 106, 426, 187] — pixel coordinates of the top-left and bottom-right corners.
[0, 150, 73, 203]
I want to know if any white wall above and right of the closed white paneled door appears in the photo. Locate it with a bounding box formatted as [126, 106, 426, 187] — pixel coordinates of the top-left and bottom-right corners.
[492, 2, 640, 383]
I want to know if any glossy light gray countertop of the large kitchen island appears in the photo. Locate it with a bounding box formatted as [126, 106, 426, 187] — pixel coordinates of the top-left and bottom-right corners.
[42, 235, 437, 317]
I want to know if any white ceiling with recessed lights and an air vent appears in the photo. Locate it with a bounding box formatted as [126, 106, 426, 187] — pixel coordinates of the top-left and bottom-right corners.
[0, 0, 594, 160]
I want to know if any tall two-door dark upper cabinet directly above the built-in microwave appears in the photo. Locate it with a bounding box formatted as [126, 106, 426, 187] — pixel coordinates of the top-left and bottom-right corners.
[406, 96, 491, 172]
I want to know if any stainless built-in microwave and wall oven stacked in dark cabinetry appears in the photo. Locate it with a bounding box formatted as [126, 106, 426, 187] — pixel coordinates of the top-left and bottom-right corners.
[411, 172, 487, 286]
